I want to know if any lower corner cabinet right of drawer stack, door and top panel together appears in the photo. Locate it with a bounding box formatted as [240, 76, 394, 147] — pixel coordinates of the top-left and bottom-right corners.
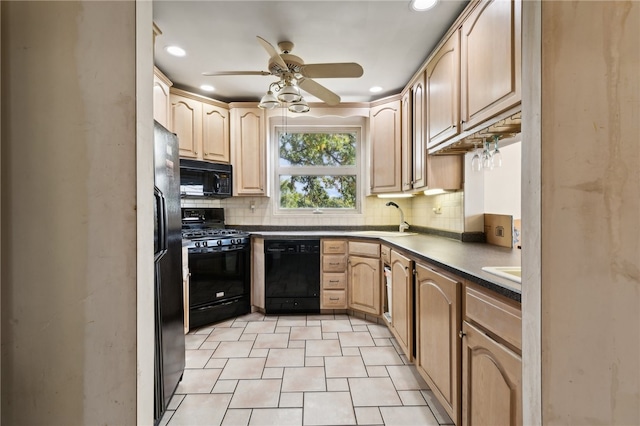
[347, 241, 382, 315]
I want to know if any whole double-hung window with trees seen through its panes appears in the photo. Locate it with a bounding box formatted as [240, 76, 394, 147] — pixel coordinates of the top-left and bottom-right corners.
[274, 126, 361, 213]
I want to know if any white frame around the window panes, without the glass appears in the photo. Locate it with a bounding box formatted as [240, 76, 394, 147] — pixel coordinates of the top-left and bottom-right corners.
[271, 120, 365, 216]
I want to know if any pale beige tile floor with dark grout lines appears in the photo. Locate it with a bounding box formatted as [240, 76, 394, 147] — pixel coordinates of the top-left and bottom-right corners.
[160, 313, 453, 426]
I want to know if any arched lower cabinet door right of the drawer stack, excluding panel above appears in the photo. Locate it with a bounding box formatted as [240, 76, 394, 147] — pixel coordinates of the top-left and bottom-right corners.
[348, 256, 382, 315]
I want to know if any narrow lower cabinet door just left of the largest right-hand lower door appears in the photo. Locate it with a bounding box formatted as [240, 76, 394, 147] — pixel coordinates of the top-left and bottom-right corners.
[391, 250, 413, 360]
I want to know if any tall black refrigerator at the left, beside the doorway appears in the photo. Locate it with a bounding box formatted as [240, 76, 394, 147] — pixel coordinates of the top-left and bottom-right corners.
[153, 122, 185, 424]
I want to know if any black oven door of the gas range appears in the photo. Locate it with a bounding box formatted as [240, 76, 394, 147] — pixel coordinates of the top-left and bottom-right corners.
[189, 245, 251, 308]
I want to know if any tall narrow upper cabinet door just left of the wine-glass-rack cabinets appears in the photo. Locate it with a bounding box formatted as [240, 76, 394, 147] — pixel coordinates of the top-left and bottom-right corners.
[411, 73, 427, 189]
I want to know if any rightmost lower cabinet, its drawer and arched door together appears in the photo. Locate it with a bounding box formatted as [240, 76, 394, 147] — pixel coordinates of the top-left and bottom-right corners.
[462, 284, 522, 426]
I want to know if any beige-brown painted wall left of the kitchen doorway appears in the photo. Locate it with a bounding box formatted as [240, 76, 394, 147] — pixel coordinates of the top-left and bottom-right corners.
[1, 1, 141, 425]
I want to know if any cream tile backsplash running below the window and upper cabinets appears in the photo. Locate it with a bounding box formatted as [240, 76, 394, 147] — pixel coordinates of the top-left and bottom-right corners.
[182, 191, 464, 232]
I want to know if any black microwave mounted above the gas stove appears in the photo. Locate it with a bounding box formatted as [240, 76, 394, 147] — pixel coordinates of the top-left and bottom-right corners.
[180, 159, 233, 198]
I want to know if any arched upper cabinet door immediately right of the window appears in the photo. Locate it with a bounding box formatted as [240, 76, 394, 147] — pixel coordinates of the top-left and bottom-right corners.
[370, 100, 402, 194]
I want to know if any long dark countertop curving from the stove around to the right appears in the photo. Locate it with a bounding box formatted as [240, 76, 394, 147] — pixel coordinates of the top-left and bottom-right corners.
[251, 230, 522, 302]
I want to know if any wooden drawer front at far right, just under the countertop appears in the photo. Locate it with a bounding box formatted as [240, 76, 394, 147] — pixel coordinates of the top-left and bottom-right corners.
[464, 284, 522, 349]
